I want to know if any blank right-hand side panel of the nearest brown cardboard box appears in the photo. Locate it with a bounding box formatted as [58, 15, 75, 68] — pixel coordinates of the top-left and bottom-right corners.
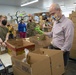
[32, 57, 51, 75]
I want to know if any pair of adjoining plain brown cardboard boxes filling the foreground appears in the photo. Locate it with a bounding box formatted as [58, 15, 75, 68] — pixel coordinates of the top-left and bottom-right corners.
[12, 48, 64, 75]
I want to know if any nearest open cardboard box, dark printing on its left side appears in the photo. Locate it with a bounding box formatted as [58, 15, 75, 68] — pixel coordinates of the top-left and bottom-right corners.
[12, 53, 51, 75]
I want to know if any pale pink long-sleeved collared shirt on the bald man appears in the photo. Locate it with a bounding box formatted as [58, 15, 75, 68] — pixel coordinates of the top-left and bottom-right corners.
[46, 15, 74, 51]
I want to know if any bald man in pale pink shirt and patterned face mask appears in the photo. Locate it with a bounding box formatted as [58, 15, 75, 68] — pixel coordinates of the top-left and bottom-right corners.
[44, 3, 74, 67]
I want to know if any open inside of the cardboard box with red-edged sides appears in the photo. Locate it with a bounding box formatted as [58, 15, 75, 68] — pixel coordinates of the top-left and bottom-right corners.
[6, 39, 34, 48]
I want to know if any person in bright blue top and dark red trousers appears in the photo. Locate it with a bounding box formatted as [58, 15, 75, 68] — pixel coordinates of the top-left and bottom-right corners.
[18, 19, 26, 38]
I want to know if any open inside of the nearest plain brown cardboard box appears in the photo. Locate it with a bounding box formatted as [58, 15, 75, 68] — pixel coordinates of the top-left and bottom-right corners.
[12, 52, 50, 66]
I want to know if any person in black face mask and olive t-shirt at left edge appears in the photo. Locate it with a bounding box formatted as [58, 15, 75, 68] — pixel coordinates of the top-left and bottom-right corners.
[0, 19, 9, 47]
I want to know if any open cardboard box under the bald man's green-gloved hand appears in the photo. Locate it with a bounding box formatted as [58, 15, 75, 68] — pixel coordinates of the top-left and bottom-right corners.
[29, 35, 51, 49]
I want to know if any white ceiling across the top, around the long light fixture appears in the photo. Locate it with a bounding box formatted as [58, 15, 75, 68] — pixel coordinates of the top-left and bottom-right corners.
[0, 0, 76, 10]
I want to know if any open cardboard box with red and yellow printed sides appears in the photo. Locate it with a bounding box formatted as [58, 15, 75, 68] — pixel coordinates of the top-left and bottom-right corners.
[6, 39, 35, 56]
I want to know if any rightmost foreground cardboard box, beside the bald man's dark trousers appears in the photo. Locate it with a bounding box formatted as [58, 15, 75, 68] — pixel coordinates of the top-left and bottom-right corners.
[33, 48, 64, 75]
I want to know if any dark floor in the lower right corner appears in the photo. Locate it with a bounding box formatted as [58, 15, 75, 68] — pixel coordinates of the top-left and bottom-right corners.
[64, 60, 76, 75]
